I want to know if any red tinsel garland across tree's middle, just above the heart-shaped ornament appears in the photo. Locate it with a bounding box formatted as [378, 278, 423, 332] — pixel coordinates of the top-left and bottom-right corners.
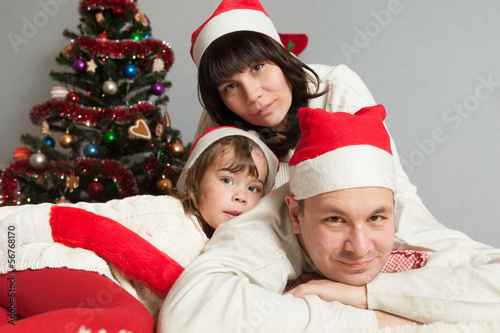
[30, 99, 157, 126]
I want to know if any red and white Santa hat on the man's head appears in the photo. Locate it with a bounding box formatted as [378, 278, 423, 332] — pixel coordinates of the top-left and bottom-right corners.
[289, 105, 396, 200]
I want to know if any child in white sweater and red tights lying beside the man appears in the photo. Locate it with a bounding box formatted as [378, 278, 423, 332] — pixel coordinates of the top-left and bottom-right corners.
[0, 127, 278, 333]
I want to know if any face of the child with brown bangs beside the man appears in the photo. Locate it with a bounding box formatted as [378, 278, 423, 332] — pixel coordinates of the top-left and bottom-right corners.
[198, 150, 267, 229]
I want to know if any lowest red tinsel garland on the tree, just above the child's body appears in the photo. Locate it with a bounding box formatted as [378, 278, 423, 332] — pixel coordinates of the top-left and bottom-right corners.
[0, 159, 139, 206]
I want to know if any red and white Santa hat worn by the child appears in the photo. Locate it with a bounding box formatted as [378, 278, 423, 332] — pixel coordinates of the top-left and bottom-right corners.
[176, 126, 279, 193]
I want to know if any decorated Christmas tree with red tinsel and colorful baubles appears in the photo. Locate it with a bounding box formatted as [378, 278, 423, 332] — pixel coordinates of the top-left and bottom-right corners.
[0, 0, 188, 205]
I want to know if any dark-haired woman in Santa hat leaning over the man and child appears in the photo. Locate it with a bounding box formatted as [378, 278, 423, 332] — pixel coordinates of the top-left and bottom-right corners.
[191, 0, 421, 204]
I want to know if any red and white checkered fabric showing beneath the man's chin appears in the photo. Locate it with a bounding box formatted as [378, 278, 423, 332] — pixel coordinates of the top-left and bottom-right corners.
[285, 250, 429, 292]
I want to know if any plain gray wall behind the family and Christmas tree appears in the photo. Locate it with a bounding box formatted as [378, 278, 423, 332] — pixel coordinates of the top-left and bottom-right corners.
[0, 0, 500, 247]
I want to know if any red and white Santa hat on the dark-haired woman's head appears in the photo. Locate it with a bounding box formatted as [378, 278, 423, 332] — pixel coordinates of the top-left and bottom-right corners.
[191, 0, 281, 66]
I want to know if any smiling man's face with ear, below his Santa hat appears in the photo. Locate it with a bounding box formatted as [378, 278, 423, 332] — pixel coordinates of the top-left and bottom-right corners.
[286, 187, 394, 286]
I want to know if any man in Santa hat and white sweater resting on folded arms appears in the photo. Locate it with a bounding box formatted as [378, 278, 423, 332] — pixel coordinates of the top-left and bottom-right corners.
[159, 105, 500, 332]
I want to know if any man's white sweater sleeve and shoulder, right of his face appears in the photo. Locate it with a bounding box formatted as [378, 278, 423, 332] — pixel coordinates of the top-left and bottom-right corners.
[367, 198, 500, 324]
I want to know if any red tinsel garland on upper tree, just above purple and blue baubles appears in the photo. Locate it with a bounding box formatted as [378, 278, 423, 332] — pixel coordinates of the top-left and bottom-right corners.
[67, 36, 174, 72]
